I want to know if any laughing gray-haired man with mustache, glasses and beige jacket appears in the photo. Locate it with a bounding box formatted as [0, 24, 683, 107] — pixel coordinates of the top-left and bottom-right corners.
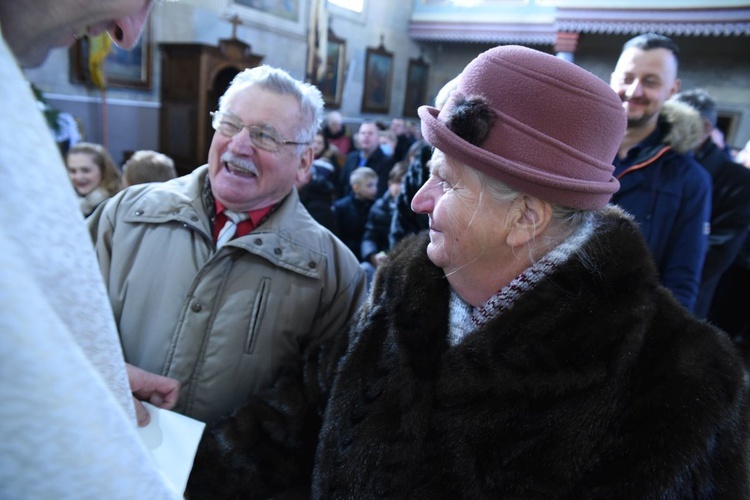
[88, 66, 365, 422]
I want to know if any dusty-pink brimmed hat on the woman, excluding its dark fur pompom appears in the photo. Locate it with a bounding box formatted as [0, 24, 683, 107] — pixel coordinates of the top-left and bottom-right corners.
[418, 46, 626, 209]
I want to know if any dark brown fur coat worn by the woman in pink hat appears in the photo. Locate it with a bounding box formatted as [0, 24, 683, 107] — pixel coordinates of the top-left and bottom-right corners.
[188, 207, 748, 500]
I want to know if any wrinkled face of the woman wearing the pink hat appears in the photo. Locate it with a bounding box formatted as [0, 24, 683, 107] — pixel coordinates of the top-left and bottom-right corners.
[411, 150, 507, 274]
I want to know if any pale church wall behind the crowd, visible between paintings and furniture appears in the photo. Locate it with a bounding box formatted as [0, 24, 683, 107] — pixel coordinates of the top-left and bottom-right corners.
[22, 0, 750, 166]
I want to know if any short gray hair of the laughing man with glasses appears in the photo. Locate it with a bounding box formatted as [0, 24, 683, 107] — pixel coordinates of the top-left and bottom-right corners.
[219, 65, 324, 143]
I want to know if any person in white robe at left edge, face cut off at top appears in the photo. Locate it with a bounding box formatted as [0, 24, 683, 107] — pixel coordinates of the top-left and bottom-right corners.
[0, 0, 181, 499]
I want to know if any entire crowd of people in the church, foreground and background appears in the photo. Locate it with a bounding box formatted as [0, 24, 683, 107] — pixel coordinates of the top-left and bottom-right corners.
[0, 0, 750, 499]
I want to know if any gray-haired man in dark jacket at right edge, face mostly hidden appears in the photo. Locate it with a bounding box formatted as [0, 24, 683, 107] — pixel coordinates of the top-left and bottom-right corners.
[674, 89, 750, 318]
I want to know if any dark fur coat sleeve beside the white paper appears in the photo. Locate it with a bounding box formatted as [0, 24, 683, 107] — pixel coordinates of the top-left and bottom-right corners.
[187, 335, 347, 500]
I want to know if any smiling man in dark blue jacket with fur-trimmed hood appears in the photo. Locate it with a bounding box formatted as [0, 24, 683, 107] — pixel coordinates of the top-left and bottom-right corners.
[610, 33, 711, 311]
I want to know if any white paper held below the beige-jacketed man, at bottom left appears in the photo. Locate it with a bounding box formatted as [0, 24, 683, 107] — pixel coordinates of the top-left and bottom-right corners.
[138, 402, 206, 492]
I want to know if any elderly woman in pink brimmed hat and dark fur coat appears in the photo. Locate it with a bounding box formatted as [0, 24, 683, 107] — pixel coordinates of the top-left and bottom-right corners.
[188, 46, 748, 499]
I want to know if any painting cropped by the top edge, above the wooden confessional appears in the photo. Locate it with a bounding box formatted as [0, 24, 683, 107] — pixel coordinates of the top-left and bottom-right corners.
[225, 0, 310, 38]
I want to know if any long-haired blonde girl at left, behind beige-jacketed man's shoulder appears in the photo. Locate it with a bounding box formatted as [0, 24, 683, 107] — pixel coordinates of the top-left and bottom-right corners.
[65, 142, 122, 217]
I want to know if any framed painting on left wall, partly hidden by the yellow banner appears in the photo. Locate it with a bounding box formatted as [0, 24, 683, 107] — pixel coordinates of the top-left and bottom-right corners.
[70, 23, 152, 90]
